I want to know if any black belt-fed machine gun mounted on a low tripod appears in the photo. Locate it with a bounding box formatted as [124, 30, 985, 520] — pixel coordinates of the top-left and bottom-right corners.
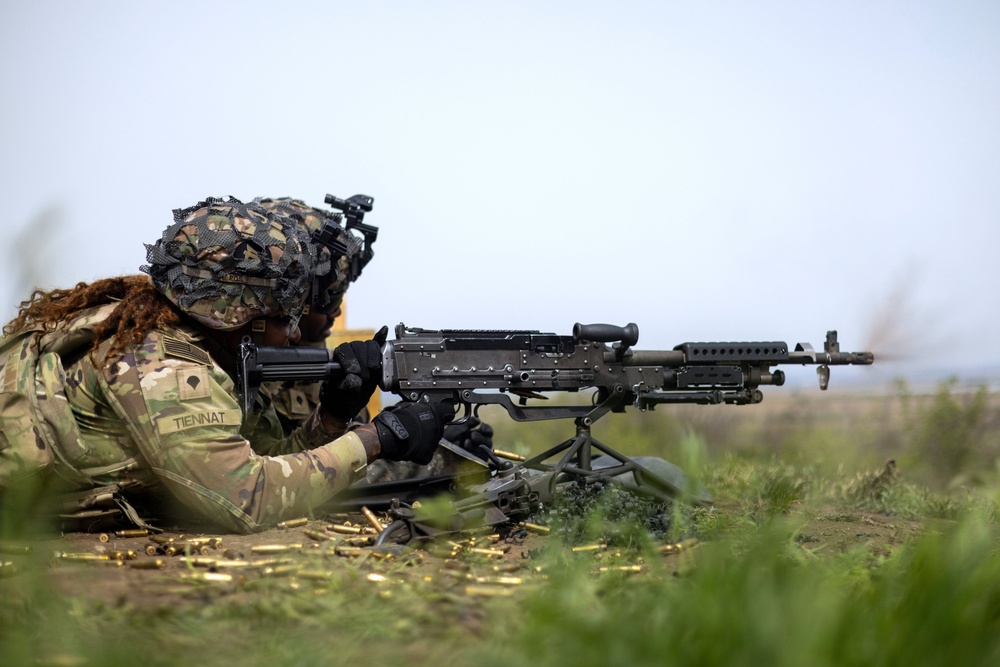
[237, 324, 874, 522]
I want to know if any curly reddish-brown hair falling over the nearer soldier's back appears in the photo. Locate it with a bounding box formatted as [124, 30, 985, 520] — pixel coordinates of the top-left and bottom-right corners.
[3, 274, 183, 366]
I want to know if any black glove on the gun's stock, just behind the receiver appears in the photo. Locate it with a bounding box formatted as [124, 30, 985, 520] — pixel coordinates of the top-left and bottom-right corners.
[319, 327, 389, 419]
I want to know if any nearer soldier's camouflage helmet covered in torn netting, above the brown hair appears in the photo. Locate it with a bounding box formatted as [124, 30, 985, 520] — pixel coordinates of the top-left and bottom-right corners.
[142, 197, 313, 329]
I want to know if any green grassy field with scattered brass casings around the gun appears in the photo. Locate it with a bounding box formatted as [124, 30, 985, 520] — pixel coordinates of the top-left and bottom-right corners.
[0, 384, 1000, 665]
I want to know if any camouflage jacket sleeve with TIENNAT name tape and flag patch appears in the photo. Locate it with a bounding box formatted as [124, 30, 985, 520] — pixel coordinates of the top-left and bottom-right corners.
[93, 331, 367, 532]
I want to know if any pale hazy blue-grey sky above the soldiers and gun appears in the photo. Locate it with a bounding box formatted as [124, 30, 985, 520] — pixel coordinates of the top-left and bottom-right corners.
[0, 0, 1000, 382]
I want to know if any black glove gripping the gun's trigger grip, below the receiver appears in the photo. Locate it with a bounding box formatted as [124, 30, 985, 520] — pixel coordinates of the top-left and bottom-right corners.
[372, 403, 455, 465]
